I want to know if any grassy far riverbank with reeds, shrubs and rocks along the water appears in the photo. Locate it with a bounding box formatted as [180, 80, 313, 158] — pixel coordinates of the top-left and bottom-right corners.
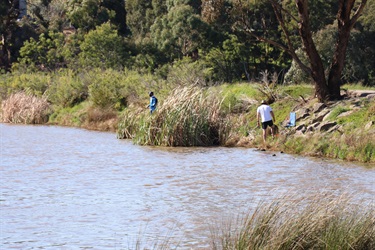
[1, 72, 375, 163]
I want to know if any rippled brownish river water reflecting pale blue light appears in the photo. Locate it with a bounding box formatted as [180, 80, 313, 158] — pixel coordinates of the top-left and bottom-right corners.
[0, 124, 375, 249]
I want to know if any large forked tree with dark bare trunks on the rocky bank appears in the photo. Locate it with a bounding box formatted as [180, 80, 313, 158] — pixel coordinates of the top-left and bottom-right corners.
[235, 0, 367, 102]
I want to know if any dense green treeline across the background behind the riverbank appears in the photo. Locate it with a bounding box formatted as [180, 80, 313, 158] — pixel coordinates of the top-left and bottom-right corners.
[0, 0, 375, 86]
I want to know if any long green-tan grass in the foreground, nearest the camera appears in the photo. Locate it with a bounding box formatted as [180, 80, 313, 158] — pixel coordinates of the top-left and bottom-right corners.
[212, 195, 375, 250]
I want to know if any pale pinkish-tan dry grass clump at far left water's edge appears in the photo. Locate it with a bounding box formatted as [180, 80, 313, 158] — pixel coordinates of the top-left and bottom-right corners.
[1, 92, 51, 124]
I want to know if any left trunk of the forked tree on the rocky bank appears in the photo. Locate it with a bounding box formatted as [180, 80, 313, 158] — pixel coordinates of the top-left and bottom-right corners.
[296, 0, 330, 102]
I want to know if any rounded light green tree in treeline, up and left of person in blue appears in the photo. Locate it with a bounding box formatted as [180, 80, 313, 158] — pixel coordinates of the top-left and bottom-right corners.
[79, 23, 126, 69]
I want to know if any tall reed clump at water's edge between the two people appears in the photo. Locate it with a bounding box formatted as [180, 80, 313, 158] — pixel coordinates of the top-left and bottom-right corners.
[118, 86, 230, 146]
